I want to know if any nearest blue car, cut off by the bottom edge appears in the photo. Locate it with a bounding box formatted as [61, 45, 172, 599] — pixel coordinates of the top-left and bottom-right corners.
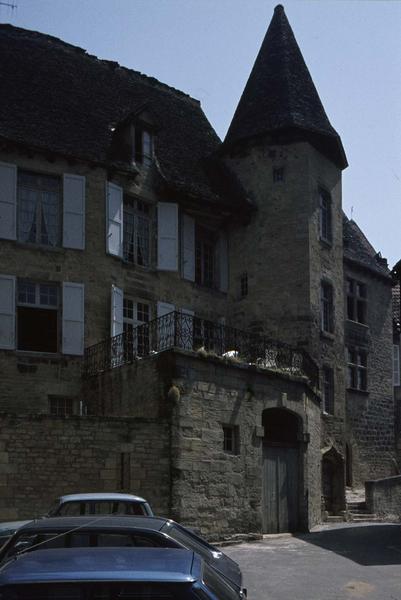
[0, 548, 243, 600]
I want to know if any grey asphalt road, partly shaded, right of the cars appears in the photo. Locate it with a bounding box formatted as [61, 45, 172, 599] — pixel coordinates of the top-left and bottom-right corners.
[224, 523, 401, 600]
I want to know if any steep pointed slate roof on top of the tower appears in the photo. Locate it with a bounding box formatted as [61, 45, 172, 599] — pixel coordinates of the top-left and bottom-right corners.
[224, 5, 347, 168]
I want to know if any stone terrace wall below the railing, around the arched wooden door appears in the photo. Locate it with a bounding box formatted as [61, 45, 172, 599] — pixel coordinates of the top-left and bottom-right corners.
[166, 353, 321, 539]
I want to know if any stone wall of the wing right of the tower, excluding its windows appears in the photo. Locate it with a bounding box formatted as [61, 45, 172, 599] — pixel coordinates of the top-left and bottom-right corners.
[345, 262, 398, 486]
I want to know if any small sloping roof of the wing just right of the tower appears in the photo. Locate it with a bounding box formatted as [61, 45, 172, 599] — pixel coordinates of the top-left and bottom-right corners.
[343, 215, 391, 282]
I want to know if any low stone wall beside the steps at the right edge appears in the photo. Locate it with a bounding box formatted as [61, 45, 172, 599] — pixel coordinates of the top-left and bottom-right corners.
[365, 476, 401, 521]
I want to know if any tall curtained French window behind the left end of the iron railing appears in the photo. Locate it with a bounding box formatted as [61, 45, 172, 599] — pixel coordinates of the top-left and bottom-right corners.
[123, 298, 150, 356]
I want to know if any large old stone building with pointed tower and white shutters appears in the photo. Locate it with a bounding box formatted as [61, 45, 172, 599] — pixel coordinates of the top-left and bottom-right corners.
[0, 6, 395, 537]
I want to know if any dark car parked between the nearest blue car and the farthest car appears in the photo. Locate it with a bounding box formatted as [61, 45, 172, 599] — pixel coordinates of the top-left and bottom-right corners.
[0, 516, 242, 591]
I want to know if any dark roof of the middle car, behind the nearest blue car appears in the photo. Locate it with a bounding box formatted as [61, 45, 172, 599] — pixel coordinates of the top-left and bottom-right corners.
[18, 515, 170, 531]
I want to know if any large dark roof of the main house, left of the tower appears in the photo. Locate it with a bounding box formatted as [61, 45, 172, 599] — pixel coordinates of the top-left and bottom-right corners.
[0, 24, 244, 212]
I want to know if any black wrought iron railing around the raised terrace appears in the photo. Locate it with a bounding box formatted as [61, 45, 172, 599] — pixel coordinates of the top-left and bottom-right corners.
[84, 312, 319, 387]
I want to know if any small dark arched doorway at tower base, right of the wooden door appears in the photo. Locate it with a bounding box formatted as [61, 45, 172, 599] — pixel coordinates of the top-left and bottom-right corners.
[322, 447, 345, 515]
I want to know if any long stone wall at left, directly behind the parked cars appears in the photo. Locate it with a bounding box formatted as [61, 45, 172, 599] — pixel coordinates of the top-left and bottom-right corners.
[0, 414, 170, 521]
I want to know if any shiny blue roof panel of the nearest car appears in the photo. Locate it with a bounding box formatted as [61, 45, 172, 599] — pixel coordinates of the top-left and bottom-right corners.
[0, 548, 196, 586]
